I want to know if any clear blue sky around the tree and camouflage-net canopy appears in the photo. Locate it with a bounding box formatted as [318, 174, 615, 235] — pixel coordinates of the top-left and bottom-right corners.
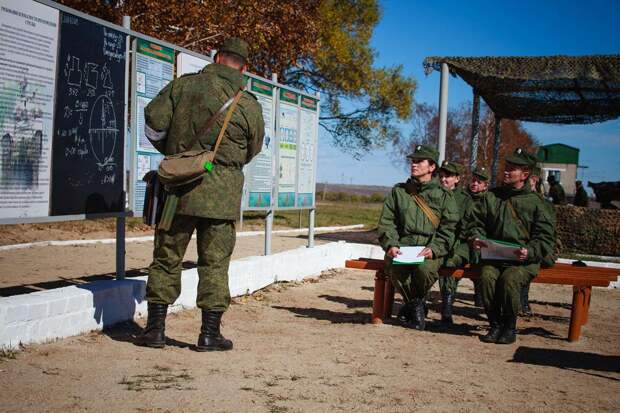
[317, 0, 620, 186]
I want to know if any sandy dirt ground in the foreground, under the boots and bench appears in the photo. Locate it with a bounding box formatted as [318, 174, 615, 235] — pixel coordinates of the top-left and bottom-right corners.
[0, 270, 620, 412]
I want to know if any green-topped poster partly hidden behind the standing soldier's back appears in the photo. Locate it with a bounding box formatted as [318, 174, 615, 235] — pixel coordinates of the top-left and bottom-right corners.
[244, 78, 275, 209]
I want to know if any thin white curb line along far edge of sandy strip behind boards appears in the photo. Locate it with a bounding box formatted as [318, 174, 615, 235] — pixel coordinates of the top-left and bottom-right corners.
[0, 224, 364, 251]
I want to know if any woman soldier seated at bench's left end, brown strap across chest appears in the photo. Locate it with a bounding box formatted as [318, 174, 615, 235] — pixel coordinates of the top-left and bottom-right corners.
[378, 145, 458, 330]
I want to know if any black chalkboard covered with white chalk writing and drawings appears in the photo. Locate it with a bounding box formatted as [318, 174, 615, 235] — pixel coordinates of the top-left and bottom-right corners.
[50, 13, 126, 215]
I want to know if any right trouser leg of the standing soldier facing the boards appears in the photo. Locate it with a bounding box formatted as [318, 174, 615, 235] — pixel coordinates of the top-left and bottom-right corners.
[196, 218, 236, 312]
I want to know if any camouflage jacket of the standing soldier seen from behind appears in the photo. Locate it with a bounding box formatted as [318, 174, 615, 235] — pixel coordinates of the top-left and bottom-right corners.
[144, 64, 265, 219]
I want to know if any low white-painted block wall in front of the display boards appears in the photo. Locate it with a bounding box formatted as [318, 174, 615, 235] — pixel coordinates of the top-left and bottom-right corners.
[0, 241, 383, 348]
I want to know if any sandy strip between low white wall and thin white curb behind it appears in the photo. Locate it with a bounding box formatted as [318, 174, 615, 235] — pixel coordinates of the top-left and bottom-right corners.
[0, 234, 330, 297]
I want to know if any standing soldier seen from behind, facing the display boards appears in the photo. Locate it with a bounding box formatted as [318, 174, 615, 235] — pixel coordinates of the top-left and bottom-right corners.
[136, 38, 264, 351]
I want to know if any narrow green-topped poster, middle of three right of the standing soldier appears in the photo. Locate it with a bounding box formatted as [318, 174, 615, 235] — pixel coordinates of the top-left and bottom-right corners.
[278, 89, 299, 208]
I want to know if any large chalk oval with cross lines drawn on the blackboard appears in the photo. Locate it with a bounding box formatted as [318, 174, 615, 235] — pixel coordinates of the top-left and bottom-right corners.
[88, 95, 119, 167]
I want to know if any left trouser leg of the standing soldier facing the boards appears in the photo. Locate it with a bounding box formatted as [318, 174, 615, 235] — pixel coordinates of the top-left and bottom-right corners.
[146, 215, 196, 304]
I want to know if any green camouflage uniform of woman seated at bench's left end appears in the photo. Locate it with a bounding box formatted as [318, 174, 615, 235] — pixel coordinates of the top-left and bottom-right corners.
[377, 145, 458, 328]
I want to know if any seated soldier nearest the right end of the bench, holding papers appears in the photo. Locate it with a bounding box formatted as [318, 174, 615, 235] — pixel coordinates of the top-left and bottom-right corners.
[467, 149, 555, 344]
